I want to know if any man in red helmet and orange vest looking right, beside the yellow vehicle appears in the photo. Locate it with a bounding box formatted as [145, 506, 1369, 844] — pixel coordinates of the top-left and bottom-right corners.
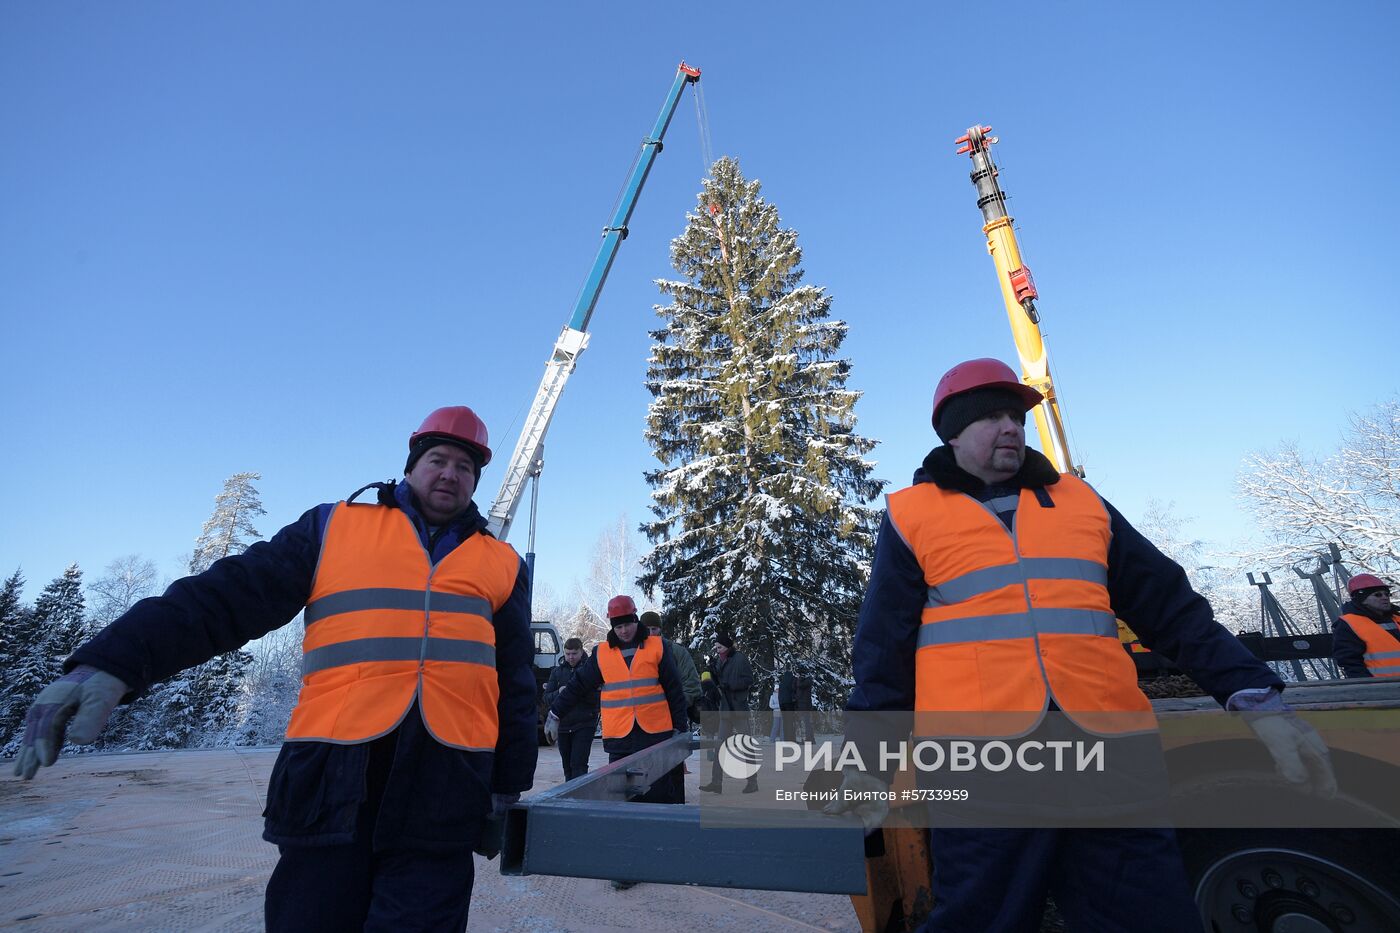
[827, 360, 1336, 933]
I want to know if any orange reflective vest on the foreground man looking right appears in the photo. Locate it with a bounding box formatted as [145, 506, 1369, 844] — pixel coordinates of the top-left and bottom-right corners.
[888, 474, 1156, 735]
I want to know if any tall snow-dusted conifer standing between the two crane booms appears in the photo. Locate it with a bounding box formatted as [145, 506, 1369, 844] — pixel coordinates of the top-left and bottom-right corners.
[638, 158, 883, 702]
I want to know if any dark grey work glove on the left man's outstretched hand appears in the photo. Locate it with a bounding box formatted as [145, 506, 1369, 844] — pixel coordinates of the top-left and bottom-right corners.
[14, 664, 130, 780]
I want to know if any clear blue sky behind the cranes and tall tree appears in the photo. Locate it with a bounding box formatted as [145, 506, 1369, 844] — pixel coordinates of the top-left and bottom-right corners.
[0, 3, 1400, 595]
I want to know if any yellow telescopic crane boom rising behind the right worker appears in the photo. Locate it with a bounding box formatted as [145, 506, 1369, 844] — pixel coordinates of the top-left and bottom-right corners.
[958, 126, 1084, 476]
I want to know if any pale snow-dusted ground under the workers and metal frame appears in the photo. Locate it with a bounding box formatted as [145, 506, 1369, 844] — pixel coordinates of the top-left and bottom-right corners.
[0, 744, 860, 933]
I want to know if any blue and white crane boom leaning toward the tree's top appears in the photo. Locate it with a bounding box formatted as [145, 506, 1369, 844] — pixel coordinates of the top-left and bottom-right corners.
[486, 62, 700, 541]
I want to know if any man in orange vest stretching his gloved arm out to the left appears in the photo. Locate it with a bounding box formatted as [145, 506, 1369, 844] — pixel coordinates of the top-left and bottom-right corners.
[15, 406, 536, 933]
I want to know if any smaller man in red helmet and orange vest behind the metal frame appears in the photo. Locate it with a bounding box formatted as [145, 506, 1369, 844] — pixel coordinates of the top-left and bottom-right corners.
[545, 595, 689, 890]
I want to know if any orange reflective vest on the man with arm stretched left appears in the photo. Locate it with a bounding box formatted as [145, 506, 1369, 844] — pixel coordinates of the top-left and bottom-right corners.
[287, 502, 519, 751]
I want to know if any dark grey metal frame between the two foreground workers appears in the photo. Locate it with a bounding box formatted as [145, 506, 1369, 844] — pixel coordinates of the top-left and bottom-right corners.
[501, 733, 867, 894]
